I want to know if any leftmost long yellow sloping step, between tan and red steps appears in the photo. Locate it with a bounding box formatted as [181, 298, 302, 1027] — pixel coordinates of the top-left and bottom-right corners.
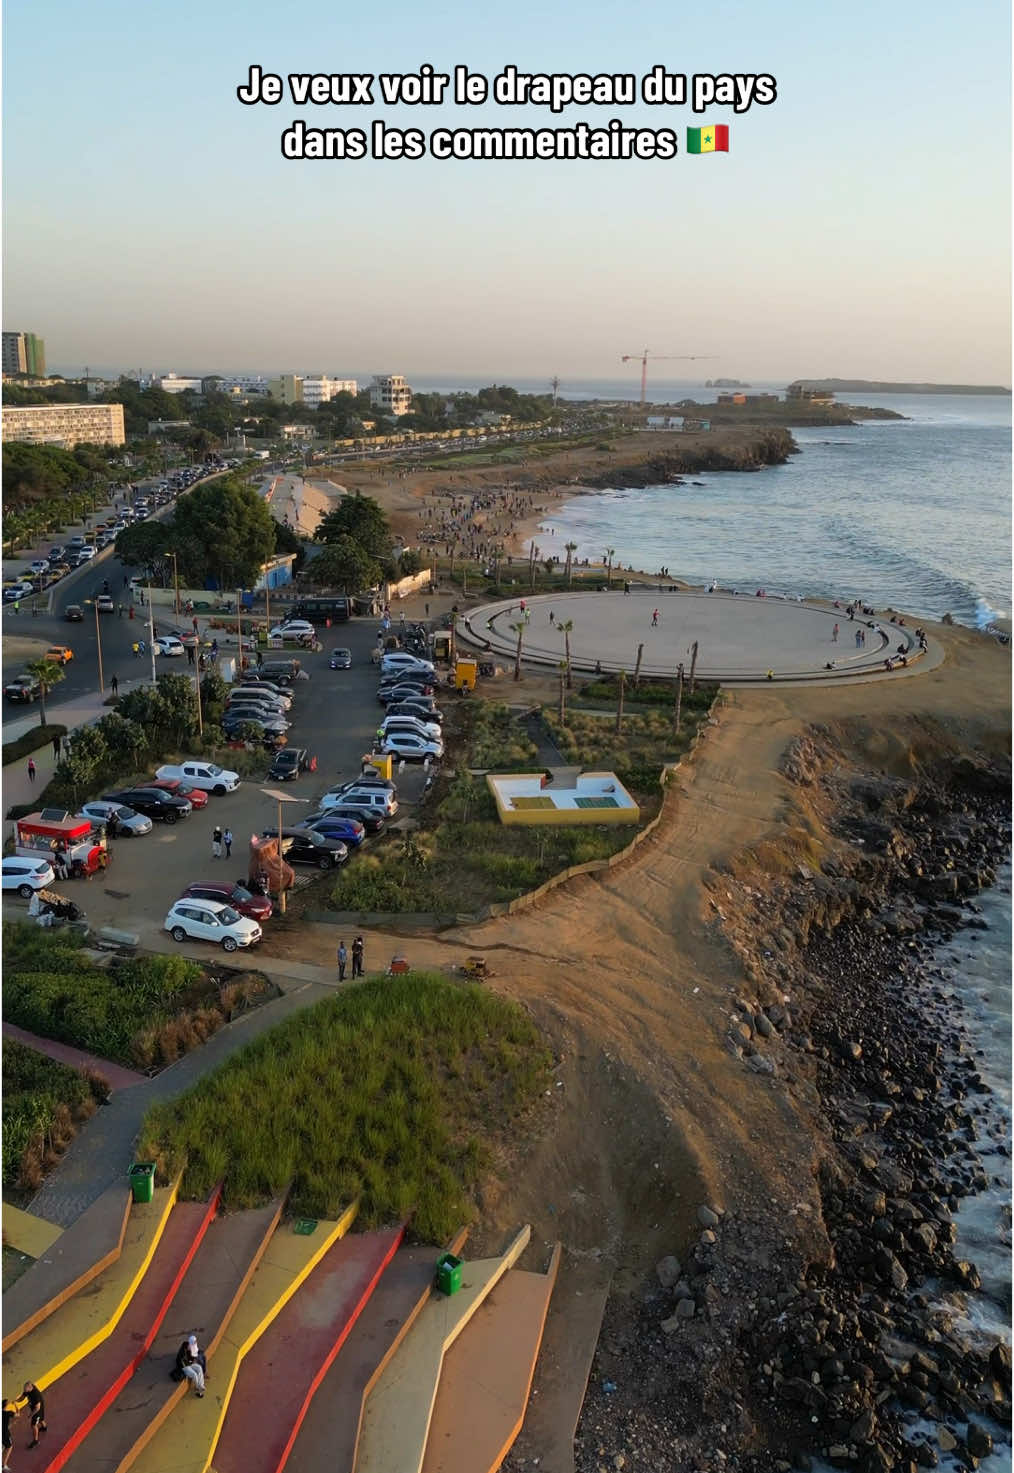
[3, 1180, 178, 1391]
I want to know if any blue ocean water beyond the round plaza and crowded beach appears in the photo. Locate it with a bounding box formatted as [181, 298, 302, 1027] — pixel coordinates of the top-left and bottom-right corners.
[535, 395, 1011, 626]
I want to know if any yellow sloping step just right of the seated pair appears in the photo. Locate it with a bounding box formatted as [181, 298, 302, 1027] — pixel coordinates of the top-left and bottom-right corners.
[131, 1203, 357, 1473]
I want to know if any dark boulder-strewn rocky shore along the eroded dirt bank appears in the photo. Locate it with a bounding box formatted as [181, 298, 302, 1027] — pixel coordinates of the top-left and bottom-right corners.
[563, 732, 1011, 1473]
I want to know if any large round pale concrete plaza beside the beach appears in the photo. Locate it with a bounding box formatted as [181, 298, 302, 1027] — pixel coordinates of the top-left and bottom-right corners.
[458, 588, 937, 682]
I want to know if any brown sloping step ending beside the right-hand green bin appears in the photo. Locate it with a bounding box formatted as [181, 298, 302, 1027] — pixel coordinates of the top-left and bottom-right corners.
[281, 1228, 467, 1473]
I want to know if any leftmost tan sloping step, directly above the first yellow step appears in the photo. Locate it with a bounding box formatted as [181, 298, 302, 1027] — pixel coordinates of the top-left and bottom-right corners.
[3, 1181, 130, 1351]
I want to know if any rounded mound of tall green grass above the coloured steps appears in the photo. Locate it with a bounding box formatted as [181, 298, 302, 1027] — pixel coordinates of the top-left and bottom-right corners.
[140, 972, 550, 1242]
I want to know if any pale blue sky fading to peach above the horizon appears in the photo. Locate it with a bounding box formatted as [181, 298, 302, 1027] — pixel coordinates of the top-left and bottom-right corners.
[4, 0, 1011, 383]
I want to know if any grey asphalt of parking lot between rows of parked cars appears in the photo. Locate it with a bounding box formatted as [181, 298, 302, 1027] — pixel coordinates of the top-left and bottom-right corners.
[4, 619, 442, 956]
